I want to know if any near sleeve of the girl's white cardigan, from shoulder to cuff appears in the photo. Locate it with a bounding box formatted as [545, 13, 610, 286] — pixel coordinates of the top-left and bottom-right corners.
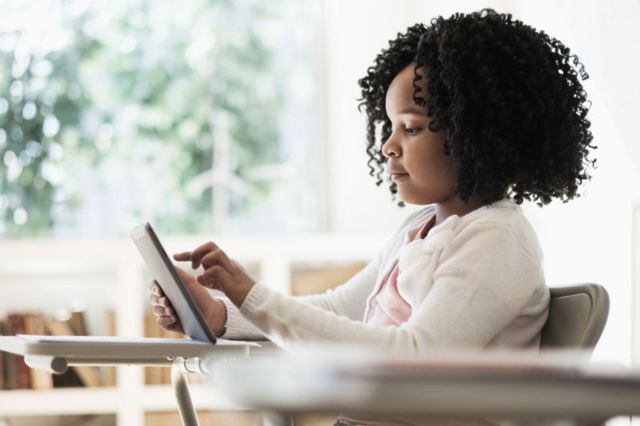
[235, 220, 540, 353]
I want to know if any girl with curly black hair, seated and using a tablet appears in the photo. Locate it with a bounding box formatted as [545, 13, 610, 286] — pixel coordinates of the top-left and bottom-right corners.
[150, 9, 594, 360]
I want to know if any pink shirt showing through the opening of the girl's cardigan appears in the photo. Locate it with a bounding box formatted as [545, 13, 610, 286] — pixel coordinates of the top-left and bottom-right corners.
[364, 214, 436, 327]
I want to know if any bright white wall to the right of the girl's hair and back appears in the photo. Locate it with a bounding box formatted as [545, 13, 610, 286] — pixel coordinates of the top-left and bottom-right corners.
[518, 0, 640, 361]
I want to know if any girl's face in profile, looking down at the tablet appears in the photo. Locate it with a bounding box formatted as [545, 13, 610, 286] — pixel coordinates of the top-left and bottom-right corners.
[382, 63, 458, 208]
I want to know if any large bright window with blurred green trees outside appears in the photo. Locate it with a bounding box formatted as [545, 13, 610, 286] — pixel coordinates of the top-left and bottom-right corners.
[0, 0, 320, 237]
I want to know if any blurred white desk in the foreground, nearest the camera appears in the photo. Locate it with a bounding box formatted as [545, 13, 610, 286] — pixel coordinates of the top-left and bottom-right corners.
[213, 352, 640, 424]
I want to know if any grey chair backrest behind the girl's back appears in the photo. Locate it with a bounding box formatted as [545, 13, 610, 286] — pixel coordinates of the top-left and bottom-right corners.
[540, 284, 609, 349]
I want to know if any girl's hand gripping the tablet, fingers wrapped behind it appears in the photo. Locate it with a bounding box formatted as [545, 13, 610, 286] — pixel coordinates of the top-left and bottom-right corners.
[149, 266, 227, 337]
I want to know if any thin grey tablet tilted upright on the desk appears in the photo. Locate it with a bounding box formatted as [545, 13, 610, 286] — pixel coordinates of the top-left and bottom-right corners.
[131, 223, 216, 343]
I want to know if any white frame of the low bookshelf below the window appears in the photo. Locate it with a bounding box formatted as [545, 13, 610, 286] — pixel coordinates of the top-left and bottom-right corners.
[0, 235, 380, 426]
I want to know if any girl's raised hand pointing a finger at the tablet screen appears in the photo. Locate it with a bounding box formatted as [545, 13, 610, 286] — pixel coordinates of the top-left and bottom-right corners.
[173, 241, 256, 307]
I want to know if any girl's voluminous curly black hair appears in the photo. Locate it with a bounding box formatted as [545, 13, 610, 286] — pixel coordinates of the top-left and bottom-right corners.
[358, 9, 596, 206]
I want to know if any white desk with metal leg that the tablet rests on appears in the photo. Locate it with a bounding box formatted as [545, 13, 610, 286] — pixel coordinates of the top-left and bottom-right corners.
[0, 335, 260, 426]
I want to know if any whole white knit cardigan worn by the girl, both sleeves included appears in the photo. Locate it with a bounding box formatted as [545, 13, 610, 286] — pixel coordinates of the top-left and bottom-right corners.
[223, 200, 549, 354]
